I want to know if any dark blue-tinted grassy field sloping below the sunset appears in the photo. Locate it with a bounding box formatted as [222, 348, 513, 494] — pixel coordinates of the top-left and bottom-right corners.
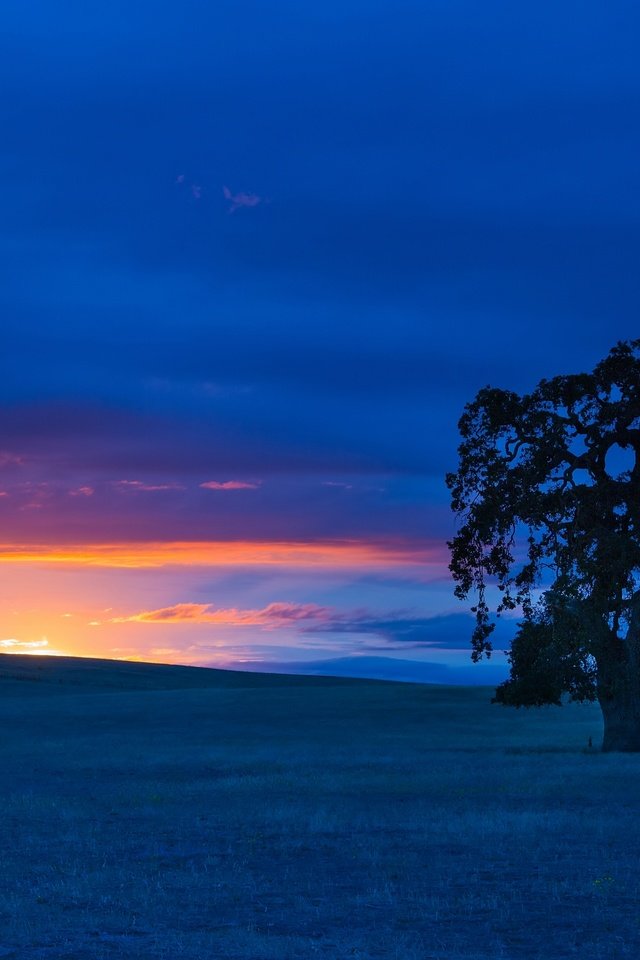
[0, 656, 640, 960]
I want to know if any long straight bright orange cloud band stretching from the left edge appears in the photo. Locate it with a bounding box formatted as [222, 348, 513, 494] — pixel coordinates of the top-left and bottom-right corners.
[0, 540, 440, 570]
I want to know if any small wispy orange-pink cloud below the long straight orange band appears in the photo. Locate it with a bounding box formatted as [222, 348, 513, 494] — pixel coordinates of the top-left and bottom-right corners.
[104, 603, 332, 627]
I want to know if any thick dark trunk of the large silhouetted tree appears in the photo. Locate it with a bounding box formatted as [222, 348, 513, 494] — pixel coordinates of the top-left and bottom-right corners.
[596, 593, 640, 753]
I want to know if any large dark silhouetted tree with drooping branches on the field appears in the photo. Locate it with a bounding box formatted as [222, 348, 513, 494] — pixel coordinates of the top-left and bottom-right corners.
[447, 340, 640, 751]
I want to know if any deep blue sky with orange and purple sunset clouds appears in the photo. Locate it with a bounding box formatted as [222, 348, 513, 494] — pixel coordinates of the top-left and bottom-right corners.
[0, 0, 640, 682]
